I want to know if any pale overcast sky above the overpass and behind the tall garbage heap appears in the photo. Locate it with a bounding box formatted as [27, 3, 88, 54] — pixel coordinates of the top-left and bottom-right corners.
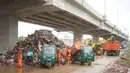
[18, 0, 130, 36]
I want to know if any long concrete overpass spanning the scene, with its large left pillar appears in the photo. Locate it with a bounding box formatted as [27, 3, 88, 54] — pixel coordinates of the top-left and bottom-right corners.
[0, 0, 128, 51]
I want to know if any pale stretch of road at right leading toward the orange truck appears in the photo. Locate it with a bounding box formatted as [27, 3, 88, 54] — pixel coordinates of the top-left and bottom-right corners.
[72, 56, 119, 73]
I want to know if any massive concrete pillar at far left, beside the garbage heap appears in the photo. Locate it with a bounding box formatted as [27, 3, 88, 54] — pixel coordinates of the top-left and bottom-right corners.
[0, 16, 18, 53]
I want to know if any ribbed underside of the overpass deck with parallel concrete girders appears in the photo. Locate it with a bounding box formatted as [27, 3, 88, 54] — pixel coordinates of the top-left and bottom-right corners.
[20, 11, 97, 31]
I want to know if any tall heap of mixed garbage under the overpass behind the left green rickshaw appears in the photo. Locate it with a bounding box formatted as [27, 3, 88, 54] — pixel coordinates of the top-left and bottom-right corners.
[0, 30, 65, 66]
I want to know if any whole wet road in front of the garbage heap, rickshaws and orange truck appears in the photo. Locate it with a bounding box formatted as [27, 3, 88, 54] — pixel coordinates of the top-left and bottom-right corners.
[0, 48, 126, 73]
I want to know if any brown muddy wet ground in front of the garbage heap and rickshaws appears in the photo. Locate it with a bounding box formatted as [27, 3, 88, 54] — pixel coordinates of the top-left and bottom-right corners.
[0, 65, 86, 73]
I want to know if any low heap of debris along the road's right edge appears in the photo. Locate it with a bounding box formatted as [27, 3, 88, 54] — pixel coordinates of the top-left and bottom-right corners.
[103, 51, 130, 73]
